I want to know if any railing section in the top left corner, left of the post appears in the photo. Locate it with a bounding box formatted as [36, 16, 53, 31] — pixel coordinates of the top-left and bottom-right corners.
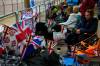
[0, 0, 24, 16]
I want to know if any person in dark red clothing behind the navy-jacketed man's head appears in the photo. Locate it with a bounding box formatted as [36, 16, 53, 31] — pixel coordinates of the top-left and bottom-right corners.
[80, 0, 96, 16]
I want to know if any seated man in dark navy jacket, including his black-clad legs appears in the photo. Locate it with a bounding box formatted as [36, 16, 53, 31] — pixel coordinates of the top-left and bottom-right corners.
[65, 9, 98, 53]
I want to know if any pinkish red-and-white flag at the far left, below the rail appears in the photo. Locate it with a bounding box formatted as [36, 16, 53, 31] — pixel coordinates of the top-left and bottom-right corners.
[2, 25, 17, 49]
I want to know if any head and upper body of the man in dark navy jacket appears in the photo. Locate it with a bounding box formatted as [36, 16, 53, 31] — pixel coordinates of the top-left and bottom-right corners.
[76, 9, 98, 38]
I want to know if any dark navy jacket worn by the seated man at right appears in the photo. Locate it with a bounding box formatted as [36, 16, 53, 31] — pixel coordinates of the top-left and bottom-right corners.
[76, 18, 98, 34]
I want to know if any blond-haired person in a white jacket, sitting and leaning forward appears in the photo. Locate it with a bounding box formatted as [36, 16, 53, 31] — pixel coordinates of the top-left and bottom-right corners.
[60, 6, 81, 29]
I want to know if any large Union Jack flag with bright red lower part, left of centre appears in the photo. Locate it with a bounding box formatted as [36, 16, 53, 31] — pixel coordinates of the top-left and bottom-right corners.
[12, 20, 32, 43]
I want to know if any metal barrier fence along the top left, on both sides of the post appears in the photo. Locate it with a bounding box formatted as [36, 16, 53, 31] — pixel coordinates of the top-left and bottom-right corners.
[0, 0, 64, 22]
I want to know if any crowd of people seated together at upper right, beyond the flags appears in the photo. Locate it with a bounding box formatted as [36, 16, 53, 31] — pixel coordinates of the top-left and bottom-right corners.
[45, 0, 100, 56]
